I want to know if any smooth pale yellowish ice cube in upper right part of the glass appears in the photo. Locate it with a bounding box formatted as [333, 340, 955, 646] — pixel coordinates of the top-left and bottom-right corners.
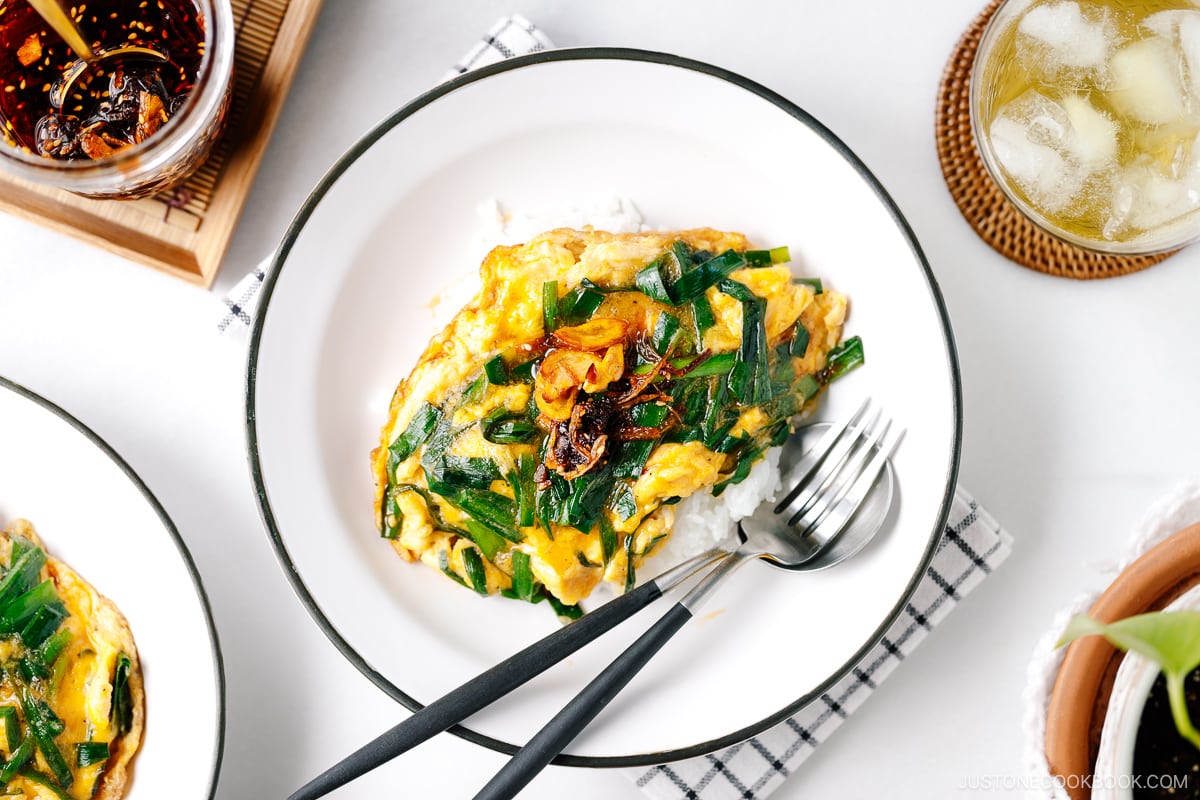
[1108, 36, 1186, 125]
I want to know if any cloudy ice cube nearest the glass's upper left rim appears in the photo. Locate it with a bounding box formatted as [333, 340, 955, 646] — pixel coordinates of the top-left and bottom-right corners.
[1016, 1, 1115, 76]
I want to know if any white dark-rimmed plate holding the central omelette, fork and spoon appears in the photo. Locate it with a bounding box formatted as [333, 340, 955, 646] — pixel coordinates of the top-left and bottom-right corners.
[246, 49, 961, 766]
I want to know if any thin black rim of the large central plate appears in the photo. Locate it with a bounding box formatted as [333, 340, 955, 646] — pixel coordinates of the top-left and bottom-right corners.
[245, 47, 962, 768]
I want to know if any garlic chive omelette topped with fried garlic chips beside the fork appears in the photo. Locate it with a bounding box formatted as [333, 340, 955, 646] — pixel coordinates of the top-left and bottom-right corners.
[372, 229, 863, 616]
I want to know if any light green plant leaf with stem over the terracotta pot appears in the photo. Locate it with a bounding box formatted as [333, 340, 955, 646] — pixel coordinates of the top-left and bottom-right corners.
[1058, 610, 1200, 748]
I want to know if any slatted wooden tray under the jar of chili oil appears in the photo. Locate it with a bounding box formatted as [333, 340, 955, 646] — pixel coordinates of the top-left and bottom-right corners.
[0, 0, 320, 287]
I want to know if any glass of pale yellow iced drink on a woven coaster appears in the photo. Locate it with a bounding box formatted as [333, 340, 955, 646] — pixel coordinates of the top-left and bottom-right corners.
[971, 0, 1200, 254]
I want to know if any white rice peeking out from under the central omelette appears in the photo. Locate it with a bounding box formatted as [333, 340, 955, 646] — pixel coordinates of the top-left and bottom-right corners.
[476, 197, 781, 582]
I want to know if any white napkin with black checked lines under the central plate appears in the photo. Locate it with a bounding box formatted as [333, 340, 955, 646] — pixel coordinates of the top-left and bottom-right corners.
[218, 16, 1012, 800]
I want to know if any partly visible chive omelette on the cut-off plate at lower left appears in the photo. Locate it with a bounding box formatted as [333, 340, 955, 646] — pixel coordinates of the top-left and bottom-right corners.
[0, 519, 144, 800]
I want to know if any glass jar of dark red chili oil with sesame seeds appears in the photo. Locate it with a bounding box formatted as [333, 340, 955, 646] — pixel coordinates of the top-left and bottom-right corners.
[0, 0, 234, 199]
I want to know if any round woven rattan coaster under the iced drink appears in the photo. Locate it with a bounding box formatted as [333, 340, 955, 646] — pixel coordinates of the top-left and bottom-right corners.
[936, 0, 1178, 278]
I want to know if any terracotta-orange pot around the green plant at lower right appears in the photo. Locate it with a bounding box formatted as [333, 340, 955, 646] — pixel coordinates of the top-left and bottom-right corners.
[1045, 524, 1200, 800]
